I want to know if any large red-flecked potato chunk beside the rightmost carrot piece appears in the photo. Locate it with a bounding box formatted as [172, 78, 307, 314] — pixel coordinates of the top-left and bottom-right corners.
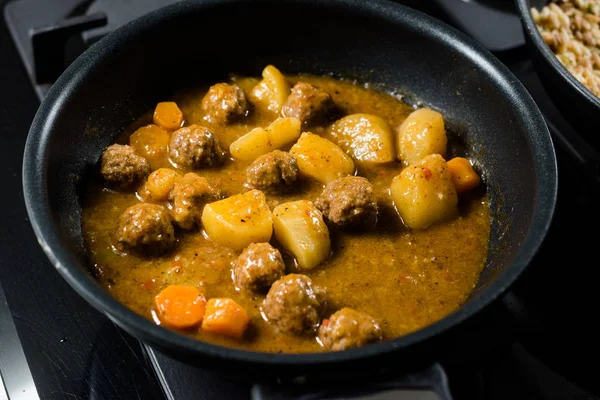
[390, 154, 458, 229]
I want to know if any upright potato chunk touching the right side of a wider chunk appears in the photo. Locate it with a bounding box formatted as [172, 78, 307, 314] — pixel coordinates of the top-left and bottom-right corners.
[273, 200, 331, 269]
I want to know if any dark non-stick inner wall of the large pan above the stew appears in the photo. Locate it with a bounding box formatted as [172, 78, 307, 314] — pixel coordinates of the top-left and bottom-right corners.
[25, 1, 556, 366]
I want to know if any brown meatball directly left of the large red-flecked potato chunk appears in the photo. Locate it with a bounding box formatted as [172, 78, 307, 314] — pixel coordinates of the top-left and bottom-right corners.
[315, 176, 377, 228]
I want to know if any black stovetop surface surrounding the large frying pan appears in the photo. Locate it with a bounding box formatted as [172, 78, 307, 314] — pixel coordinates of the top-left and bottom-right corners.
[0, 0, 600, 400]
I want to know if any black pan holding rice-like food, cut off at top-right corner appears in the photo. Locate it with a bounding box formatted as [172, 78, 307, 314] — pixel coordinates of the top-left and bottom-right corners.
[516, 0, 600, 149]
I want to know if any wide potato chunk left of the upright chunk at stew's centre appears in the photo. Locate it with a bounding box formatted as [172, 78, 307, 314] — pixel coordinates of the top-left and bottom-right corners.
[202, 190, 273, 250]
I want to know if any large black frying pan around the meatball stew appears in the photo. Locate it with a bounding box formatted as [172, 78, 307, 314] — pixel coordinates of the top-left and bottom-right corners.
[23, 0, 557, 396]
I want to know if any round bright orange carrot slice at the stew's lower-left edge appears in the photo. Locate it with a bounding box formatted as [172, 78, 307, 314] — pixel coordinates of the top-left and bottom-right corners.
[154, 285, 206, 329]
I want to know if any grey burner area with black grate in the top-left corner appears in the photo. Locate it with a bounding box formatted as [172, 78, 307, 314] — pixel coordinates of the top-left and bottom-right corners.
[4, 0, 177, 98]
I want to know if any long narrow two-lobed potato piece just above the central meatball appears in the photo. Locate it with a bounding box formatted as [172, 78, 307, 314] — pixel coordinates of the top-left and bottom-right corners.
[229, 118, 302, 161]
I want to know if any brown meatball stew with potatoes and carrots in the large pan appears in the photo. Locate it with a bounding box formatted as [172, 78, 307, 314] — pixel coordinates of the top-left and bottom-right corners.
[82, 66, 490, 353]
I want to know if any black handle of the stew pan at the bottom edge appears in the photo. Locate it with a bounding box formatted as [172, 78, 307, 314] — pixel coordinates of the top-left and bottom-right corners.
[251, 363, 452, 400]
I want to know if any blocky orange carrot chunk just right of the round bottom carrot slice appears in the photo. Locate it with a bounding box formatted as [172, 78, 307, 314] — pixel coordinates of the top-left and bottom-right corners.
[202, 298, 250, 339]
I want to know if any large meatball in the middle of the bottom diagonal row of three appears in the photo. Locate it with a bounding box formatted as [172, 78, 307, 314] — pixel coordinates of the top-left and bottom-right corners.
[263, 274, 325, 335]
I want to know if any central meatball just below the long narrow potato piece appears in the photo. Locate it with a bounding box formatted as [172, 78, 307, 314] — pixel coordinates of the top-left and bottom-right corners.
[246, 150, 300, 191]
